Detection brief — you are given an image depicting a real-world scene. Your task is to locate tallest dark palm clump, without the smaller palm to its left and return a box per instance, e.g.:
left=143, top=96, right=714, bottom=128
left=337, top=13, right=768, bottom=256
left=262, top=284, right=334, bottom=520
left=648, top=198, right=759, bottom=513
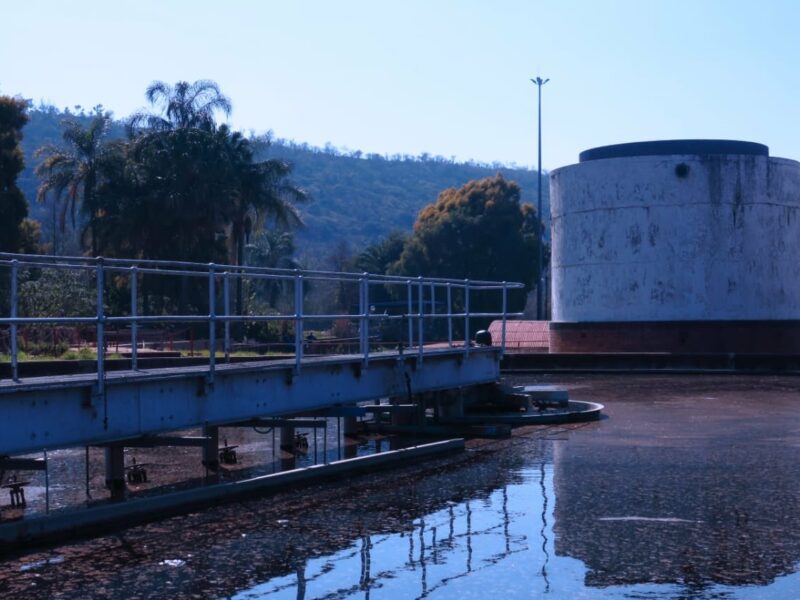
left=114, top=80, right=306, bottom=312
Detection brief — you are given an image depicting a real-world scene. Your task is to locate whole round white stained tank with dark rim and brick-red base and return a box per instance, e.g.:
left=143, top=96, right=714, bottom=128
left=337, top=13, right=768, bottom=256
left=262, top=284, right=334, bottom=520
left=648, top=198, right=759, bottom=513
left=550, top=140, right=800, bottom=353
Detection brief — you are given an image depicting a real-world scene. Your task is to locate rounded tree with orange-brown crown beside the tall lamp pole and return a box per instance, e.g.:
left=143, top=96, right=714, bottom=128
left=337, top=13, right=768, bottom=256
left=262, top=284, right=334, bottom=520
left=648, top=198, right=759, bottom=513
left=390, top=174, right=541, bottom=312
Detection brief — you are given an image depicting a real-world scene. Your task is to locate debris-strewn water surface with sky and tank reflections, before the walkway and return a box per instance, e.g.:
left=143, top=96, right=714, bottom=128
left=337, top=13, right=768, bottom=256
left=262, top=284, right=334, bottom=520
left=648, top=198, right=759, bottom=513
left=0, top=376, right=800, bottom=599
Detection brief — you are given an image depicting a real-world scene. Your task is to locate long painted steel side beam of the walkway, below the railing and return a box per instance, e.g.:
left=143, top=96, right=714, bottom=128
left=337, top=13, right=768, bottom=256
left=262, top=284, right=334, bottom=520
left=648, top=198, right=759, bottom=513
left=0, top=348, right=501, bottom=455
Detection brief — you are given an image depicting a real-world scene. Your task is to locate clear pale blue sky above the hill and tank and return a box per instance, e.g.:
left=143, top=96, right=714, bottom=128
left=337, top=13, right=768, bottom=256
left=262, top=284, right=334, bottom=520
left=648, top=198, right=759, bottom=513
left=0, top=0, right=800, bottom=169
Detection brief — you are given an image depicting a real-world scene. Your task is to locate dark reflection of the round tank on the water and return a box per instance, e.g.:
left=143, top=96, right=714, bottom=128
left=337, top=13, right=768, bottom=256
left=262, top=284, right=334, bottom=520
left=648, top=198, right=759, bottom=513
left=553, top=378, right=800, bottom=597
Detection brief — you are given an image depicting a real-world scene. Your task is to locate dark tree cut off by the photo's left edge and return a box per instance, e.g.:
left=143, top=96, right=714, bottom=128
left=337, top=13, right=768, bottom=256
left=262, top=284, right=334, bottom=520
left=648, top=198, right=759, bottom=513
left=0, top=96, right=28, bottom=252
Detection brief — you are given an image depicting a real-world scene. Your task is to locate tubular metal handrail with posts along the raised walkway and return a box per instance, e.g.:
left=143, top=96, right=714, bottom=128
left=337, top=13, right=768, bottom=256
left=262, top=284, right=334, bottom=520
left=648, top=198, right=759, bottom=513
left=0, top=253, right=523, bottom=382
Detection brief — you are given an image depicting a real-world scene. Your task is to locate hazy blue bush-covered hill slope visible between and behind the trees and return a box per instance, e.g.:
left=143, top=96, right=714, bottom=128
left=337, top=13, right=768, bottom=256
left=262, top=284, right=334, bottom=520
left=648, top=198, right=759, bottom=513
left=19, top=106, right=549, bottom=264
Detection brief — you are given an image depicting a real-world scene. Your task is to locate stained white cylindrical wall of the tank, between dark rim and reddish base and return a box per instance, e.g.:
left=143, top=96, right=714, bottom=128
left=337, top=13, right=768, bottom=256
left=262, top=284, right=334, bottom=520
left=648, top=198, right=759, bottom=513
left=550, top=154, right=800, bottom=322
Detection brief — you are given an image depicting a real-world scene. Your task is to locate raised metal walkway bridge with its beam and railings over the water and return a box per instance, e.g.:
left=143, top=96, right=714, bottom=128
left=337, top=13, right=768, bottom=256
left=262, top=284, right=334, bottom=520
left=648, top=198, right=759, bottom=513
left=0, top=254, right=522, bottom=465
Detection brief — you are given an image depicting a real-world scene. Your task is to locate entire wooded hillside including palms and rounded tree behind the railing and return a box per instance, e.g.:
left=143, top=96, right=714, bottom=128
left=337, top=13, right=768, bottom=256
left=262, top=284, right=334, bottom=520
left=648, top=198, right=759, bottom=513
left=0, top=80, right=542, bottom=350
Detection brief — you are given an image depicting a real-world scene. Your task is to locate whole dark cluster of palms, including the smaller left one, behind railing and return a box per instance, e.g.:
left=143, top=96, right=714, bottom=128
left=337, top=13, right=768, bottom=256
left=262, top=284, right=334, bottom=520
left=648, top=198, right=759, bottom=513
left=21, top=81, right=306, bottom=322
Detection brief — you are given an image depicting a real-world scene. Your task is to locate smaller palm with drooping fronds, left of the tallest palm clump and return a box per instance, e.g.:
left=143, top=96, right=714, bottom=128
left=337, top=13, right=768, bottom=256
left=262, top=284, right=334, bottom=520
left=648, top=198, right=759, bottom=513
left=35, top=113, right=111, bottom=255
